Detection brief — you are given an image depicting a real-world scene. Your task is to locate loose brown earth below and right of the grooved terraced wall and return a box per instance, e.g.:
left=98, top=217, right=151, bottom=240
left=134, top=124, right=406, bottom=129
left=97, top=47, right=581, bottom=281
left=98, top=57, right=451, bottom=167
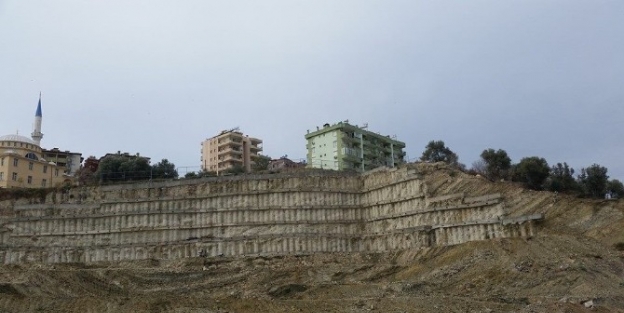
left=0, top=164, right=624, bottom=312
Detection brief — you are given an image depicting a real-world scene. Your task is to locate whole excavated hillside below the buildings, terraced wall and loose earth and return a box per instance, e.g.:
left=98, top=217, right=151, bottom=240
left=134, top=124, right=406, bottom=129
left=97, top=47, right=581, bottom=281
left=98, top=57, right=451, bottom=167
left=0, top=163, right=624, bottom=312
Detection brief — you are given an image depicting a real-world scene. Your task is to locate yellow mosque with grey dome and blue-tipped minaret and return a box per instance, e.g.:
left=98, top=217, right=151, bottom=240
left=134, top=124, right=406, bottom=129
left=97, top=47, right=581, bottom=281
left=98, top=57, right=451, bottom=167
left=0, top=94, right=82, bottom=188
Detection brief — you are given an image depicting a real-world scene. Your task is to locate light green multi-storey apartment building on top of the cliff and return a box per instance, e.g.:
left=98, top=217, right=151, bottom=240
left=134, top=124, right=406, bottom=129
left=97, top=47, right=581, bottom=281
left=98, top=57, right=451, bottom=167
left=305, top=121, right=405, bottom=172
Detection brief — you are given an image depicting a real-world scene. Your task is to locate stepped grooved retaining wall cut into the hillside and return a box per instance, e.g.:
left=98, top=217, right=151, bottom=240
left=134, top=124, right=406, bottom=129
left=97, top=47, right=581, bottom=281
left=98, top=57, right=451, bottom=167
left=0, top=168, right=541, bottom=264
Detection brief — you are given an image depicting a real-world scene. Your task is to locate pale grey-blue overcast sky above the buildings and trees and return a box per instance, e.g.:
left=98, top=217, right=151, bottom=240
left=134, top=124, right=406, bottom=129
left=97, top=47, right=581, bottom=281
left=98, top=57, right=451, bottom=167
left=0, top=0, right=624, bottom=180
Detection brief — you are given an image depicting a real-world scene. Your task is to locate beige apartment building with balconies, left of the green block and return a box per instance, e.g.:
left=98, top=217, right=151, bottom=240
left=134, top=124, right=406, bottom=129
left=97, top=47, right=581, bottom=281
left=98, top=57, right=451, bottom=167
left=201, top=128, right=262, bottom=174
